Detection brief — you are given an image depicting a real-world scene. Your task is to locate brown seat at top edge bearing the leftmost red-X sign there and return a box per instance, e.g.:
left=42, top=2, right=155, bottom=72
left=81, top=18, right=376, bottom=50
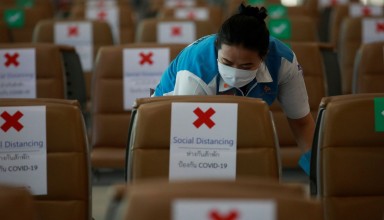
left=70, top=1, right=136, bottom=44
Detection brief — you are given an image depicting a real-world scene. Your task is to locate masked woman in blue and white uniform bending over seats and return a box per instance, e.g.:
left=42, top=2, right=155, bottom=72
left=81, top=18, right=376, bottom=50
left=154, top=4, right=314, bottom=173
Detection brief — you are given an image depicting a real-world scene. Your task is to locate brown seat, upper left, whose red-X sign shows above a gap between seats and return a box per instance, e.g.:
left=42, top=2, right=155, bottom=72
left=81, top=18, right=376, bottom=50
left=33, top=19, right=113, bottom=118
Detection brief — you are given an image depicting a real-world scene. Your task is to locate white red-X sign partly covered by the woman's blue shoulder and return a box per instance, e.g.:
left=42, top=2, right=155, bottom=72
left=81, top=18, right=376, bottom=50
left=123, top=48, right=170, bottom=110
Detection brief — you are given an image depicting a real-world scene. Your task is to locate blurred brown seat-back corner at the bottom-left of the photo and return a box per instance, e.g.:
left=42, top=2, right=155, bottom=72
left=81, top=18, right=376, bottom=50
left=0, top=184, right=38, bottom=220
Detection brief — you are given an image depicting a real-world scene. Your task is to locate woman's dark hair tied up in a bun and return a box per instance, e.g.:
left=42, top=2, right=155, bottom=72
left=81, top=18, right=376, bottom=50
left=216, top=3, right=269, bottom=58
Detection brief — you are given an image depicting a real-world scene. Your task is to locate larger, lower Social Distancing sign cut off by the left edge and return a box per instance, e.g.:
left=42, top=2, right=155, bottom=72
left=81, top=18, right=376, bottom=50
left=0, top=106, right=47, bottom=195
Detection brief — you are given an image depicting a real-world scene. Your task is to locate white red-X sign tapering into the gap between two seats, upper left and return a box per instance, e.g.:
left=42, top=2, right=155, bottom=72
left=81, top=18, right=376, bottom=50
left=54, top=22, right=93, bottom=72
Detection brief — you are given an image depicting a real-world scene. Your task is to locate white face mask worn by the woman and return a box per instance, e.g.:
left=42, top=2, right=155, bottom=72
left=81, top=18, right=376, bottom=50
left=217, top=61, right=257, bottom=88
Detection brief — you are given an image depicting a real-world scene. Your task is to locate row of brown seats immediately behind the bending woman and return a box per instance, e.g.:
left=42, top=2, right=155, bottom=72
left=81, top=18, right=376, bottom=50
left=1, top=37, right=383, bottom=169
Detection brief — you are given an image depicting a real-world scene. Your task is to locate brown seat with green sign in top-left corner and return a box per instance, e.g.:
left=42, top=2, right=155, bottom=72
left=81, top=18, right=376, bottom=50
left=0, top=5, right=54, bottom=43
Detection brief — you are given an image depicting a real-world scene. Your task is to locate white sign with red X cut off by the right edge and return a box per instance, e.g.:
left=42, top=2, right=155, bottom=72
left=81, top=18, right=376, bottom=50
left=362, top=18, right=384, bottom=43
